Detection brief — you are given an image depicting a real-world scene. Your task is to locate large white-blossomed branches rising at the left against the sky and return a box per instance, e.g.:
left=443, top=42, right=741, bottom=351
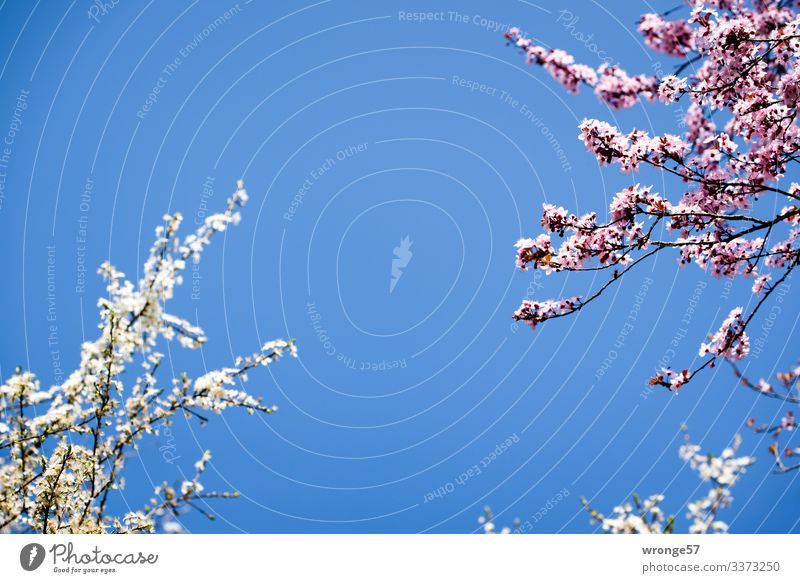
left=0, top=181, right=296, bottom=533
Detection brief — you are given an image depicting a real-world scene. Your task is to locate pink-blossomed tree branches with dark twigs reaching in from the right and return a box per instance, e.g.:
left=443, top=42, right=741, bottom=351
left=505, top=0, right=800, bottom=471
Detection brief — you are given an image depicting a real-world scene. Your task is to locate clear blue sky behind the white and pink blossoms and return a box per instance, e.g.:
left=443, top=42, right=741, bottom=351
left=0, top=0, right=800, bottom=533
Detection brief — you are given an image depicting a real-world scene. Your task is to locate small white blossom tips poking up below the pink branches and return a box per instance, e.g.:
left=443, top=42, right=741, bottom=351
left=478, top=434, right=755, bottom=534
